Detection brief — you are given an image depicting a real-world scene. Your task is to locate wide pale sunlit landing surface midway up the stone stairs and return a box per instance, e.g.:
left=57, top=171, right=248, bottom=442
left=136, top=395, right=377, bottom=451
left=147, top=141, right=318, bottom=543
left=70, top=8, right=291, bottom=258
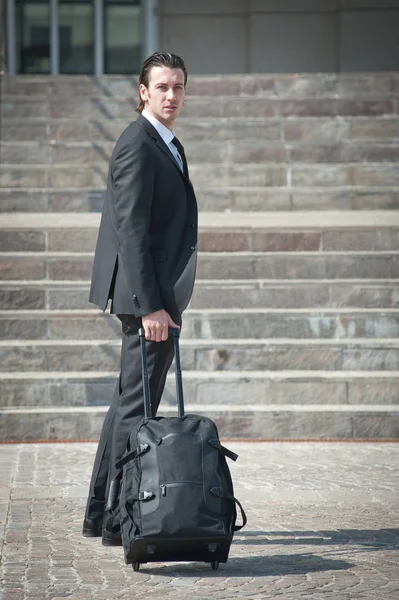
left=0, top=210, right=399, bottom=230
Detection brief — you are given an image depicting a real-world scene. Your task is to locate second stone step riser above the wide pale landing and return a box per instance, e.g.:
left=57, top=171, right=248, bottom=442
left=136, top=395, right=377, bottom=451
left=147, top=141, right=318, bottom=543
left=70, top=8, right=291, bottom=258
left=0, top=160, right=399, bottom=190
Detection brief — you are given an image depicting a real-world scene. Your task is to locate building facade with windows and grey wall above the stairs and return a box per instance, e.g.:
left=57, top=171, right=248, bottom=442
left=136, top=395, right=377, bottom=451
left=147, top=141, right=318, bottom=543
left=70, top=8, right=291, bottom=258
left=1, top=0, right=399, bottom=75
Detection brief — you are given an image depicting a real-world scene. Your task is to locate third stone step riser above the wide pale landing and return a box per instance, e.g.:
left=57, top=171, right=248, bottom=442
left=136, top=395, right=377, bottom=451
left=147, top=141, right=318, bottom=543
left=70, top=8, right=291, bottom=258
left=0, top=141, right=399, bottom=166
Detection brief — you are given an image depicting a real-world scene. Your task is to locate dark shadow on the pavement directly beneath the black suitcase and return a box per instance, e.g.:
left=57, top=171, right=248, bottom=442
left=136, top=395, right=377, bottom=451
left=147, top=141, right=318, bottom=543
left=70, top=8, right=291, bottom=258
left=140, top=553, right=354, bottom=578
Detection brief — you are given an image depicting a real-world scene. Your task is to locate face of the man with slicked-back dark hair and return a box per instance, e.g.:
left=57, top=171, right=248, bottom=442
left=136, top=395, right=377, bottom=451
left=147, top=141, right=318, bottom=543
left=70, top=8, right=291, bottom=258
left=139, top=66, right=185, bottom=131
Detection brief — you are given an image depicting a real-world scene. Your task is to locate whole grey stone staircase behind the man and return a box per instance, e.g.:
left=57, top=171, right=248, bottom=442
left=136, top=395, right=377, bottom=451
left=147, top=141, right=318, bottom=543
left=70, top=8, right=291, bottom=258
left=0, top=73, right=399, bottom=441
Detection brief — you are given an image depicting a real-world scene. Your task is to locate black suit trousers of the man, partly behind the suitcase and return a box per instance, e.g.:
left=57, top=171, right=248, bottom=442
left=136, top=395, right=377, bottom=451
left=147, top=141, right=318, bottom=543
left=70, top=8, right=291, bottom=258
left=85, top=315, right=180, bottom=521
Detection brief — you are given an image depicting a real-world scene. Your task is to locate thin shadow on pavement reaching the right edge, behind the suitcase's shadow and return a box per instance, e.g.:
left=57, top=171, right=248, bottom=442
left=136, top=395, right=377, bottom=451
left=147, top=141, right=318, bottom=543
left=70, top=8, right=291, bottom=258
left=238, top=529, right=399, bottom=550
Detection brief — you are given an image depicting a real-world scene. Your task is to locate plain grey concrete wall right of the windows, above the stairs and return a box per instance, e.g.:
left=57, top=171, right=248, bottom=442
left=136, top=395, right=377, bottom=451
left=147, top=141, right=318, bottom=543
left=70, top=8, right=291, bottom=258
left=160, top=0, right=399, bottom=74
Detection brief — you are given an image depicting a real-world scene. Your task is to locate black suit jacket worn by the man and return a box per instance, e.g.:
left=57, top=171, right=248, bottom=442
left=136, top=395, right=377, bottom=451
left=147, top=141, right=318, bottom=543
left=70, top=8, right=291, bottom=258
left=89, top=115, right=198, bottom=318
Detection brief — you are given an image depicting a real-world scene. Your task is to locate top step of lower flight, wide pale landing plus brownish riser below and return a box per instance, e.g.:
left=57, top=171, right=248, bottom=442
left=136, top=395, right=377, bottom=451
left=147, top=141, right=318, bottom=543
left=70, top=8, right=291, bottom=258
left=0, top=211, right=399, bottom=253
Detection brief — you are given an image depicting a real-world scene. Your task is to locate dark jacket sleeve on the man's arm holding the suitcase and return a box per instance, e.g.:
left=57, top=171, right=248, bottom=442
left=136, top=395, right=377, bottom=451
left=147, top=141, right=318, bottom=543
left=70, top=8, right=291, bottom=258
left=111, top=141, right=163, bottom=317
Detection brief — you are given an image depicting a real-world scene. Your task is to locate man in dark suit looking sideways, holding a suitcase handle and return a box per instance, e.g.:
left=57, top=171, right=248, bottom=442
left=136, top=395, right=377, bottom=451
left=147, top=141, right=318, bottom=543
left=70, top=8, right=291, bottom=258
left=83, top=52, right=197, bottom=545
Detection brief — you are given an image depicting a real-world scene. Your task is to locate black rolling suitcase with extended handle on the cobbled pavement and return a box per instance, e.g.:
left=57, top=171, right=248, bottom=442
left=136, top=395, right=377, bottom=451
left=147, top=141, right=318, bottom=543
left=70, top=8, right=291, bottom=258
left=108, top=329, right=246, bottom=571
